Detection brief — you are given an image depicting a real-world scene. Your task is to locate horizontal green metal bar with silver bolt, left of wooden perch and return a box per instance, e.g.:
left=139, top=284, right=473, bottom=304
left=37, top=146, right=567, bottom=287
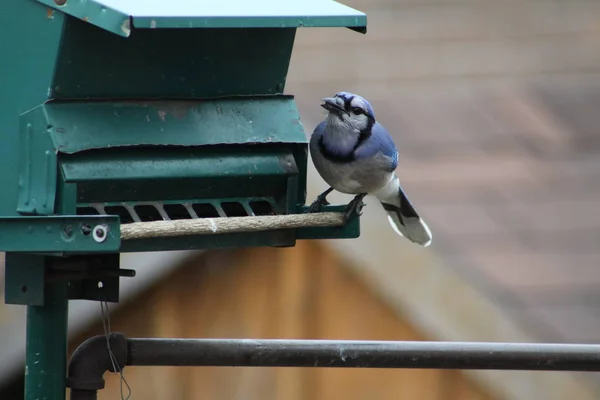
left=0, top=215, right=121, bottom=253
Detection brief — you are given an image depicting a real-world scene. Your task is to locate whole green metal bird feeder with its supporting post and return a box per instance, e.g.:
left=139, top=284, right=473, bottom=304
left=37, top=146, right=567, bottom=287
left=0, top=0, right=366, bottom=400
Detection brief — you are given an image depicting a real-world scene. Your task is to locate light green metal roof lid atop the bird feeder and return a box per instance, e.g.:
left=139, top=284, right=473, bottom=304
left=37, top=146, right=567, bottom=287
left=37, top=0, right=367, bottom=37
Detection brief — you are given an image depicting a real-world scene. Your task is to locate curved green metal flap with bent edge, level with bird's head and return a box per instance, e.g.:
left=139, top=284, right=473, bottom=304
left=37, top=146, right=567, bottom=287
left=32, top=96, right=306, bottom=154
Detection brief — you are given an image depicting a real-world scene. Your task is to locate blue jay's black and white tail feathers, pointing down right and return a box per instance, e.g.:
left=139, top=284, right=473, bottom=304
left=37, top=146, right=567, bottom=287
left=376, top=176, right=432, bottom=247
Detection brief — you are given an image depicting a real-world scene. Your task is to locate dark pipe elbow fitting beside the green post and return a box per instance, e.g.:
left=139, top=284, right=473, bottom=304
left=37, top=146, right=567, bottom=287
left=67, top=332, right=129, bottom=400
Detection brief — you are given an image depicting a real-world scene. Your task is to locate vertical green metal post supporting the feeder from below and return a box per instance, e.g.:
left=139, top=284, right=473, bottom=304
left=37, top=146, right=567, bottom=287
left=25, top=281, right=68, bottom=400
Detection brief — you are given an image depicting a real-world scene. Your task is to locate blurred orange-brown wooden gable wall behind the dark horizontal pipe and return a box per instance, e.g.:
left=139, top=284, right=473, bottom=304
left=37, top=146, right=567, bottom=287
left=70, top=242, right=491, bottom=400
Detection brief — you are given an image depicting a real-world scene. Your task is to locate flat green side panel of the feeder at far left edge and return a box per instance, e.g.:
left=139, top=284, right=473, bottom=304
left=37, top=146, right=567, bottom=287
left=0, top=0, right=64, bottom=216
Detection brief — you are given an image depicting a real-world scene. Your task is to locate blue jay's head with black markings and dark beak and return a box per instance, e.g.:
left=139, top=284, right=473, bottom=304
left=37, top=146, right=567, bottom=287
left=321, top=92, right=375, bottom=131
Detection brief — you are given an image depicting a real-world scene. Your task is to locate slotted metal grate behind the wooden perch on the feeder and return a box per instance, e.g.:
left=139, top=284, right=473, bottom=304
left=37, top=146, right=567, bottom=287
left=77, top=199, right=279, bottom=224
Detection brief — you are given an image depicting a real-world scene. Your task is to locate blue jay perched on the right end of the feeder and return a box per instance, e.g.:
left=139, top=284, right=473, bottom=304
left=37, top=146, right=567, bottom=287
left=308, top=92, right=432, bottom=247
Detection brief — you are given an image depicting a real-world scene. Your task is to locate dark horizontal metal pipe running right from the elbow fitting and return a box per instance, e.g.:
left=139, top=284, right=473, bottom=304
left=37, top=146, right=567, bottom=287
left=128, top=339, right=600, bottom=371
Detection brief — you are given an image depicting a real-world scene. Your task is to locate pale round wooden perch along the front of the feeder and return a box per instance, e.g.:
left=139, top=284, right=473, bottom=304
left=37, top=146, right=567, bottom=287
left=121, top=212, right=346, bottom=240
